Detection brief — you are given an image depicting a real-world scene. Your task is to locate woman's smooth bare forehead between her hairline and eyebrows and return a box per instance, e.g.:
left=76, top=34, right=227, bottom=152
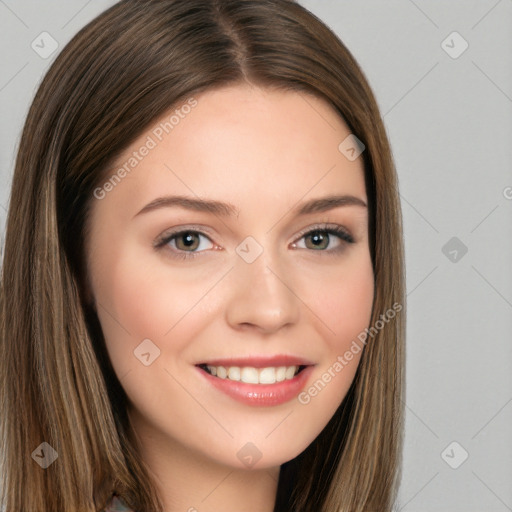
left=97, top=85, right=366, bottom=218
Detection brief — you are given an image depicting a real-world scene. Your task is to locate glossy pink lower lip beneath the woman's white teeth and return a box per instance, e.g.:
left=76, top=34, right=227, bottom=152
left=196, top=366, right=313, bottom=406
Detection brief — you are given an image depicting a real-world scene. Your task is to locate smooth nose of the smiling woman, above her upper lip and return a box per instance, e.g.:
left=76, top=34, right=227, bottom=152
left=226, top=250, right=301, bottom=334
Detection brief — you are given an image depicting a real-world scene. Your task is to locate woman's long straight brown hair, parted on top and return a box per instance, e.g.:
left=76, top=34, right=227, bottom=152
left=0, top=0, right=405, bottom=512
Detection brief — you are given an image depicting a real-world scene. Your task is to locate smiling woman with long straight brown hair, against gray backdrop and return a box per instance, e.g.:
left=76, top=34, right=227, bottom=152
left=0, top=0, right=405, bottom=512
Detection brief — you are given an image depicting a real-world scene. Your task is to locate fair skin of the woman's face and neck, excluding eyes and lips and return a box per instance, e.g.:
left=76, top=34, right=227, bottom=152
left=86, top=85, right=374, bottom=512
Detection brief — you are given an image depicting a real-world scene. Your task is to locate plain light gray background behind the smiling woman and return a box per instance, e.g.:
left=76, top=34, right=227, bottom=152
left=0, top=0, right=512, bottom=512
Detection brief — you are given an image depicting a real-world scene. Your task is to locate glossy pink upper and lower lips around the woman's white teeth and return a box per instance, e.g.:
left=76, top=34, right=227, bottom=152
left=196, top=356, right=314, bottom=406
